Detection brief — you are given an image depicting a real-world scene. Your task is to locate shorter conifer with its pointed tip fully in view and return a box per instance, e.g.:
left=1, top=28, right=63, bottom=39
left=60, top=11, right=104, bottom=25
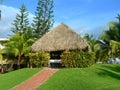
left=11, top=4, right=29, bottom=35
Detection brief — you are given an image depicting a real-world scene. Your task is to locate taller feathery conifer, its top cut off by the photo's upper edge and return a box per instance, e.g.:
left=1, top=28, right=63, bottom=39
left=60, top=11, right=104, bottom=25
left=32, top=0, right=54, bottom=39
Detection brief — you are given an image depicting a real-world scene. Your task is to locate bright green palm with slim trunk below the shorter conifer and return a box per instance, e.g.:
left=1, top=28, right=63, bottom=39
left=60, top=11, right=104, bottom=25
left=6, top=34, right=34, bottom=68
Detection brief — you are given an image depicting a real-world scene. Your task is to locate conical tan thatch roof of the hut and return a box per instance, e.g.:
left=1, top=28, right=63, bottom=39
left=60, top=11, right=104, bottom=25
left=31, top=23, right=88, bottom=52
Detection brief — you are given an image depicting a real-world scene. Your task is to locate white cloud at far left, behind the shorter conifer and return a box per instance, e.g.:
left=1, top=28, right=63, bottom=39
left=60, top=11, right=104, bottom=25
left=0, top=5, right=34, bottom=38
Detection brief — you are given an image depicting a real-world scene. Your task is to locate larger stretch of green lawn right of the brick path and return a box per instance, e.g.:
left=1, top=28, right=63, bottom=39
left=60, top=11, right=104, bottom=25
left=38, top=64, right=120, bottom=90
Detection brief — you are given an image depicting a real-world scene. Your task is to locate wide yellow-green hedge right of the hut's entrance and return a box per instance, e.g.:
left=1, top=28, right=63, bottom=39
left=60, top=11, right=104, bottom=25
left=61, top=51, right=95, bottom=68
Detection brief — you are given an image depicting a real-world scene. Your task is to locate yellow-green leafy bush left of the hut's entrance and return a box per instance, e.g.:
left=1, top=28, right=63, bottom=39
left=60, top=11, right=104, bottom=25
left=29, top=52, right=50, bottom=67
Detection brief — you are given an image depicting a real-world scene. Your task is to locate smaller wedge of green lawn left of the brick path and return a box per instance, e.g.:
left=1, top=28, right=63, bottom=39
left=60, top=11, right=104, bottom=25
left=0, top=68, right=41, bottom=90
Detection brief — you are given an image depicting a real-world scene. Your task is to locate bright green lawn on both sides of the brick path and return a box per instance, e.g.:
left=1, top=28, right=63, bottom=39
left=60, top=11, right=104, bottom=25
left=0, top=64, right=120, bottom=90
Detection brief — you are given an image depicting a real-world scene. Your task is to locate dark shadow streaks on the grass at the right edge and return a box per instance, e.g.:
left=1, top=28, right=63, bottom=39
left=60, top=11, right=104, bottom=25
left=98, top=65, right=120, bottom=80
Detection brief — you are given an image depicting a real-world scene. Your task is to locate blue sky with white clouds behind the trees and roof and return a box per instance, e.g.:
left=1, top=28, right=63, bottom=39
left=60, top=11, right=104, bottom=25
left=0, top=0, right=120, bottom=37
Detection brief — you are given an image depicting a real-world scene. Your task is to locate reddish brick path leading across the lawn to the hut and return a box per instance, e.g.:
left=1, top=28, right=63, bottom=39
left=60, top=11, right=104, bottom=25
left=12, top=68, right=58, bottom=90
